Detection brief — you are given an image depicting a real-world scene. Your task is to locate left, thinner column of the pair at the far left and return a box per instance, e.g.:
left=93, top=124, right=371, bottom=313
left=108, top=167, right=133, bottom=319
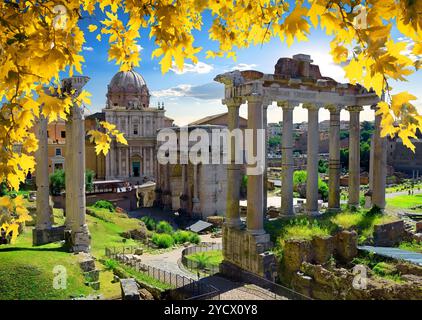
left=35, top=113, right=53, bottom=230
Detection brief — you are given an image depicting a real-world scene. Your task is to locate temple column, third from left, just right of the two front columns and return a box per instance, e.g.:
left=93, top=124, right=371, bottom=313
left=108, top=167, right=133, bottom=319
left=277, top=101, right=294, bottom=216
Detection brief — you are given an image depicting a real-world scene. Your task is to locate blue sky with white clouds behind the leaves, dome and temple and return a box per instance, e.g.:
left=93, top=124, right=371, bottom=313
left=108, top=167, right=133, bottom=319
left=77, top=7, right=422, bottom=125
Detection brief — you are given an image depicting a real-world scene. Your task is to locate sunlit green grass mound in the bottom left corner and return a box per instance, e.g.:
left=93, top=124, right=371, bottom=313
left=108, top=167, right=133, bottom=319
left=0, top=228, right=94, bottom=300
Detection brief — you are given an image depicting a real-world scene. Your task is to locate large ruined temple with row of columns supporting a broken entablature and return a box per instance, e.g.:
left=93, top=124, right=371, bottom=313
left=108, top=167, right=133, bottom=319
left=215, top=54, right=385, bottom=279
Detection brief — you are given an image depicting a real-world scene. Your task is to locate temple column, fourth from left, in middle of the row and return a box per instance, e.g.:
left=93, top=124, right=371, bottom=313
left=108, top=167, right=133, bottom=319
left=303, top=103, right=319, bottom=215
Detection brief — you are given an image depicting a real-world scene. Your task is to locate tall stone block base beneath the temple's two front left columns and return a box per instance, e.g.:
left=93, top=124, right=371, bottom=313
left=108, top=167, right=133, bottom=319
left=220, top=225, right=276, bottom=280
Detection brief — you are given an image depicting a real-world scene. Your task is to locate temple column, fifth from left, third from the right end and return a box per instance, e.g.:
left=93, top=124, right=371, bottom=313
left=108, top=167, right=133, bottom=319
left=327, top=105, right=341, bottom=212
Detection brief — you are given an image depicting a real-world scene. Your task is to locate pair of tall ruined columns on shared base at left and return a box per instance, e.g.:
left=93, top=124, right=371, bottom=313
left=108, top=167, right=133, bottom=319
left=33, top=76, right=91, bottom=252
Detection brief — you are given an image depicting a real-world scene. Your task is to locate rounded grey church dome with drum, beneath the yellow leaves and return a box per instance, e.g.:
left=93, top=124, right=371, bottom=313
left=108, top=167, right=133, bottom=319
left=107, top=70, right=150, bottom=109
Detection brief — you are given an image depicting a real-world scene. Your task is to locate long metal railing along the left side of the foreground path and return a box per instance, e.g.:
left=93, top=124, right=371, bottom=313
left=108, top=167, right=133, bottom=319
left=105, top=247, right=220, bottom=300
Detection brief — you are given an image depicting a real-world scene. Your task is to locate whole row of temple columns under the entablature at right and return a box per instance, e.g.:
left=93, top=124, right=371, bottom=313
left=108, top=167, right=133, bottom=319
left=223, top=96, right=386, bottom=224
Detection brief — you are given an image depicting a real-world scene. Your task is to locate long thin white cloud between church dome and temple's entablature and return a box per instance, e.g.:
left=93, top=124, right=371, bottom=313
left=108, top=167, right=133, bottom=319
left=152, top=82, right=224, bottom=100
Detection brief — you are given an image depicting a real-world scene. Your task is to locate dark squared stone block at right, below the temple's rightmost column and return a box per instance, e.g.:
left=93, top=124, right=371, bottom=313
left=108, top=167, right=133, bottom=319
left=374, top=220, right=406, bottom=247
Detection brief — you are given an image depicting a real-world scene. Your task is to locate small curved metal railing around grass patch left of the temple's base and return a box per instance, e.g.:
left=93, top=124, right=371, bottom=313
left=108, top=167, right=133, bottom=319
left=181, top=242, right=223, bottom=275
